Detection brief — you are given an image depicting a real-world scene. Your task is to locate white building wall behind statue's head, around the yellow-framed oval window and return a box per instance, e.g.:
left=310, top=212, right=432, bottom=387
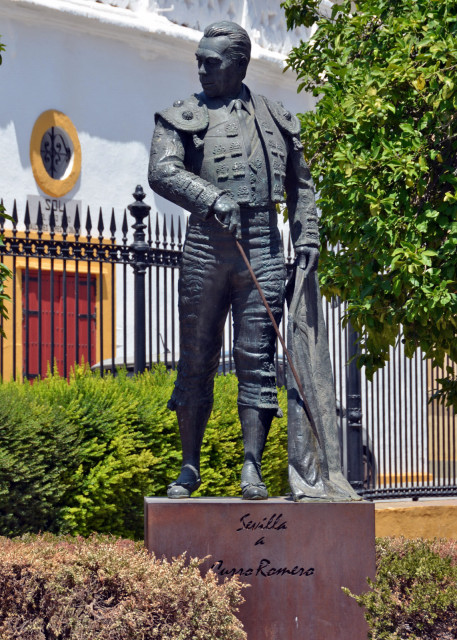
left=0, top=0, right=311, bottom=228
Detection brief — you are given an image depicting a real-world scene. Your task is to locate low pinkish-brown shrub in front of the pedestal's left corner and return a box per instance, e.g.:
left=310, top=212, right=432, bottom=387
left=0, top=534, right=246, bottom=640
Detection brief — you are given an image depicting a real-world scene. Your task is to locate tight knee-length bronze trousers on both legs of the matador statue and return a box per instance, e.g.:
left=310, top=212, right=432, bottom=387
left=168, top=208, right=286, bottom=411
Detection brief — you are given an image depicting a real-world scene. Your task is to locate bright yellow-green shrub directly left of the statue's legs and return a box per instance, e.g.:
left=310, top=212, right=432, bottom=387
left=35, top=368, right=166, bottom=538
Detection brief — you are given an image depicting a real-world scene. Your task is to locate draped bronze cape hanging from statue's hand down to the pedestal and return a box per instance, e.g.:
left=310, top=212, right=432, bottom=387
left=287, top=267, right=361, bottom=502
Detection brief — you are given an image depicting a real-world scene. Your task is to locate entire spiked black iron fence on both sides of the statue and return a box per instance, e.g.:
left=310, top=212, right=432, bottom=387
left=0, top=188, right=457, bottom=499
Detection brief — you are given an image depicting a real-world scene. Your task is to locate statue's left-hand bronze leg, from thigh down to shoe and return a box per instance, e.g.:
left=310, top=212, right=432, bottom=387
left=167, top=227, right=230, bottom=498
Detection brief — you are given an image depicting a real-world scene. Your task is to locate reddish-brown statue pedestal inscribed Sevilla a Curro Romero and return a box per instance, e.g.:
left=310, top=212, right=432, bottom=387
left=145, top=498, right=375, bottom=640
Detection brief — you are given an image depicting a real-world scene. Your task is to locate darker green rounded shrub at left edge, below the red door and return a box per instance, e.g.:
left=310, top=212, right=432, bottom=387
left=0, top=383, right=80, bottom=535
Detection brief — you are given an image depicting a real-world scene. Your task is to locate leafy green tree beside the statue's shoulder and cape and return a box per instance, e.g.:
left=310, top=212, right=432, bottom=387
left=281, top=0, right=457, bottom=408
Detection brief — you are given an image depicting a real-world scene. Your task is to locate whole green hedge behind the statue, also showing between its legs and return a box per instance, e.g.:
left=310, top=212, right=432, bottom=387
left=0, top=366, right=288, bottom=538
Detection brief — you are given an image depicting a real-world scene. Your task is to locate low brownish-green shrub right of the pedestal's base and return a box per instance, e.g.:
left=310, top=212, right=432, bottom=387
left=345, top=538, right=457, bottom=640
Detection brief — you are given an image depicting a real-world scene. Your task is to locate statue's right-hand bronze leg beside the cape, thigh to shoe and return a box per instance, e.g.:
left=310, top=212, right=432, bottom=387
left=232, top=225, right=285, bottom=500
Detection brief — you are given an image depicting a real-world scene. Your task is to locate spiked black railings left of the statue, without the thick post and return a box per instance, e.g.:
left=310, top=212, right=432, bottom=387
left=0, top=189, right=183, bottom=380
